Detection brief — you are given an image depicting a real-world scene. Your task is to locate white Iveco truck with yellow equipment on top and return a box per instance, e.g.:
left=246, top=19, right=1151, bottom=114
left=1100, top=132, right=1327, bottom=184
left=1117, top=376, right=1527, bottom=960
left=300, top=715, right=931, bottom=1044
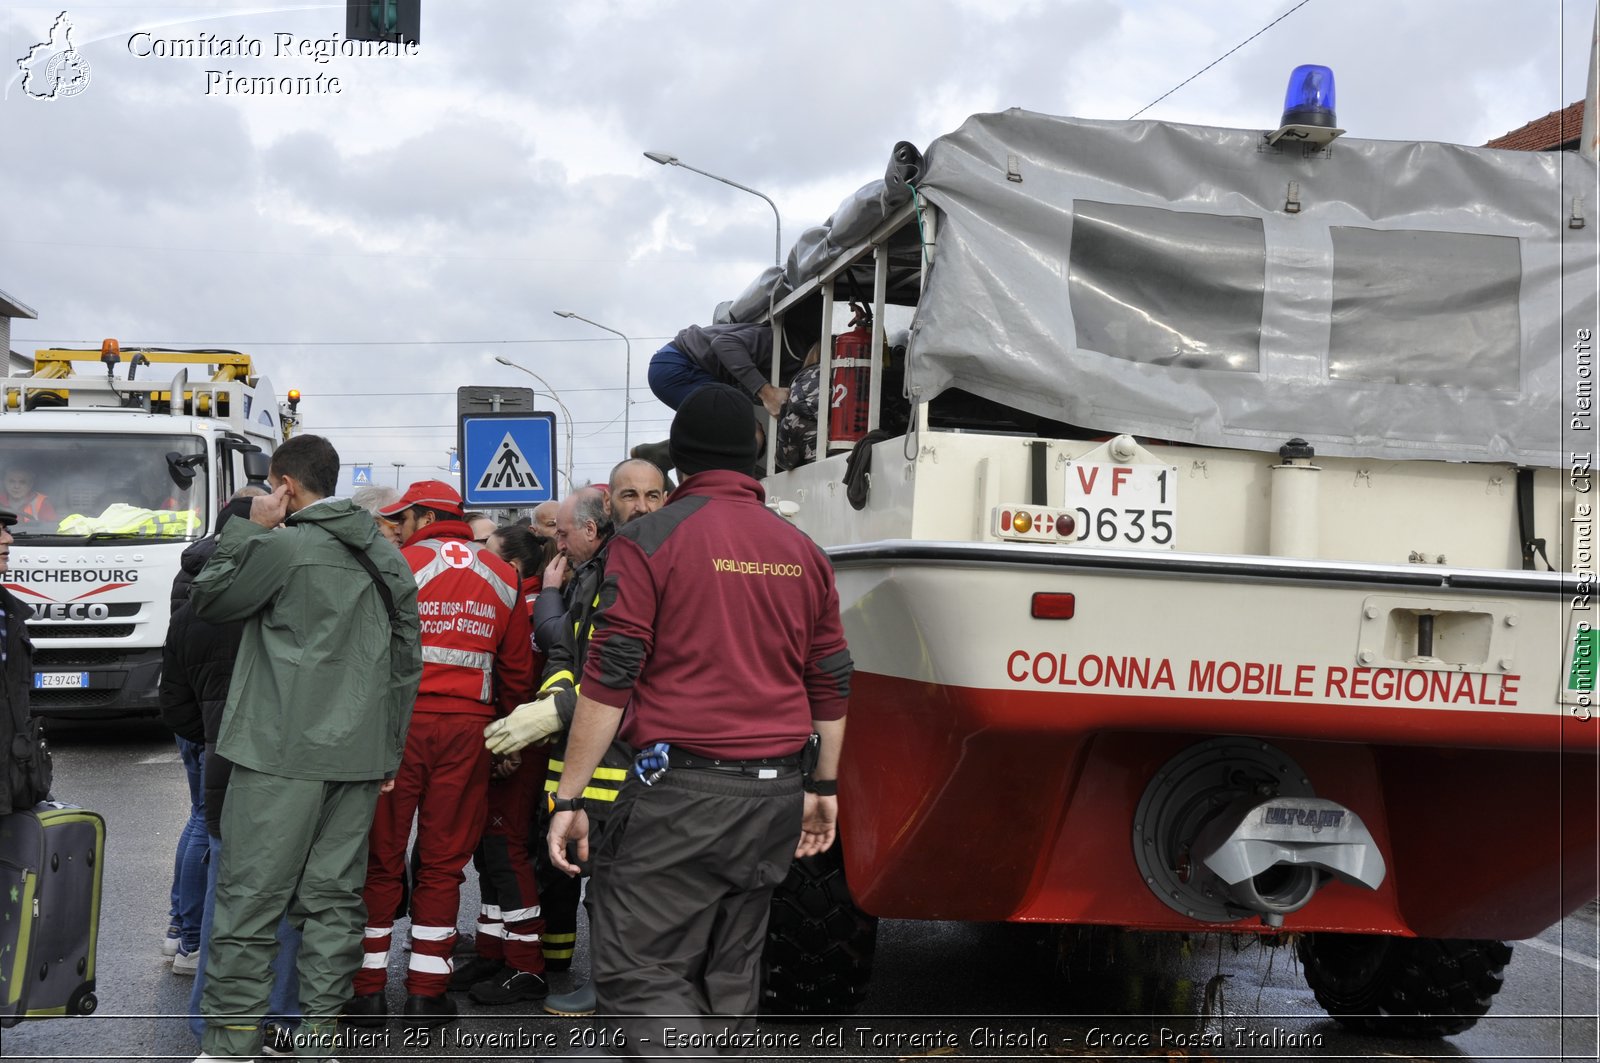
left=0, top=339, right=299, bottom=719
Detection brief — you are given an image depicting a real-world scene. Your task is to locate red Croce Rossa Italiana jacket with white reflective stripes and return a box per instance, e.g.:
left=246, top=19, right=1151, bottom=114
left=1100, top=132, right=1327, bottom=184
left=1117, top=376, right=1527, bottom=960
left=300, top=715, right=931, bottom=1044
left=400, top=520, right=536, bottom=717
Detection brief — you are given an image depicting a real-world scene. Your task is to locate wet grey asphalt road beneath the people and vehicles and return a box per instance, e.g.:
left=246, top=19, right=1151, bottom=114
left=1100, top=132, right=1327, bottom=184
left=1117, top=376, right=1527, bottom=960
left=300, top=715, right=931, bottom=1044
left=0, top=722, right=1600, bottom=1061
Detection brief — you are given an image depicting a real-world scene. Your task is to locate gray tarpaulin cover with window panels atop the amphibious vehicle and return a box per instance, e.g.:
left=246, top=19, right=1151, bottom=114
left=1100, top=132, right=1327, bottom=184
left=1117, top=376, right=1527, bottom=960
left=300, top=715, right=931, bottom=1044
left=746, top=110, right=1597, bottom=466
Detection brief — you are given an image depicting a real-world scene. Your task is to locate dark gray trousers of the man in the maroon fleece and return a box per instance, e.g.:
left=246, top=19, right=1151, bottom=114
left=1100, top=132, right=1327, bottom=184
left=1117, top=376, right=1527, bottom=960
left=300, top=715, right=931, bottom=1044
left=589, top=768, right=803, bottom=1057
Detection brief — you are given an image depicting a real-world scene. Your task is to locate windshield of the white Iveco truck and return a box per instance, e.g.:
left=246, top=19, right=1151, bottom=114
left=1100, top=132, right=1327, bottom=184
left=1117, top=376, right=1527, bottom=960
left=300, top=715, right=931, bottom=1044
left=0, top=432, right=211, bottom=541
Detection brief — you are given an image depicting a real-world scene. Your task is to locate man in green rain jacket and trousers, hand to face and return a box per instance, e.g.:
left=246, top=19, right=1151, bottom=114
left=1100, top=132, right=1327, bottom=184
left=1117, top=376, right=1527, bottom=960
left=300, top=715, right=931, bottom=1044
left=190, top=435, right=422, bottom=1058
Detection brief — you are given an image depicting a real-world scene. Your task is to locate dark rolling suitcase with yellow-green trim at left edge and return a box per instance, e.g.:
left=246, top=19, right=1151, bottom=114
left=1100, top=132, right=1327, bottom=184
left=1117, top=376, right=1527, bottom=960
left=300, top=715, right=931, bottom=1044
left=0, top=802, right=106, bottom=1028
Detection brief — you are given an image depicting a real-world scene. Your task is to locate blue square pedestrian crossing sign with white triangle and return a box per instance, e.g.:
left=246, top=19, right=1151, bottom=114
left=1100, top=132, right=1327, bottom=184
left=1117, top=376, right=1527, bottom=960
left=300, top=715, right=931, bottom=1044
left=458, top=413, right=555, bottom=506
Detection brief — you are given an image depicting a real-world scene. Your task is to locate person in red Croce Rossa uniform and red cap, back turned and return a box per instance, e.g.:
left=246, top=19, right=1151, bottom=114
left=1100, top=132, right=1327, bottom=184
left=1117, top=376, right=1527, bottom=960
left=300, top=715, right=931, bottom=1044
left=346, top=480, right=538, bottom=1025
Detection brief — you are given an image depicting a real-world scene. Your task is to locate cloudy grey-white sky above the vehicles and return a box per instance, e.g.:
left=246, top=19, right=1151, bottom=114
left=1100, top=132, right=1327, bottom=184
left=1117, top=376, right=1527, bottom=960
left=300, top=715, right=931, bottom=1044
left=0, top=0, right=1595, bottom=490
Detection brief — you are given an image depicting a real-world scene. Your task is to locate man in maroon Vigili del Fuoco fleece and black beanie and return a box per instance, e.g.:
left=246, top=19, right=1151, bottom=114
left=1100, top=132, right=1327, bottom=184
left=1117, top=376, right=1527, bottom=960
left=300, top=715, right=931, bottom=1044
left=549, top=384, right=851, bottom=1055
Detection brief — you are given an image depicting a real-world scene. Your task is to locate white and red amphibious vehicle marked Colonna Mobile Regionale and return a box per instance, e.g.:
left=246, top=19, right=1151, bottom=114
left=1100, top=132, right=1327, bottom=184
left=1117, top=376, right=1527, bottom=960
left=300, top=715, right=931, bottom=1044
left=748, top=67, right=1600, bottom=1034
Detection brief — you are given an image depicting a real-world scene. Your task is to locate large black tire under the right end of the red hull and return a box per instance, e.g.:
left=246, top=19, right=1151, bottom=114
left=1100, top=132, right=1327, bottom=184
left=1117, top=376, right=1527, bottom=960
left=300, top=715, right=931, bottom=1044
left=1298, top=933, right=1510, bottom=1037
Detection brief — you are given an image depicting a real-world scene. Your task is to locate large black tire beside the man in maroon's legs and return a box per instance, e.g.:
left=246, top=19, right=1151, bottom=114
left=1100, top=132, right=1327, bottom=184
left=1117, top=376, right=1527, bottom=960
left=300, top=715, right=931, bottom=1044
left=762, top=842, right=878, bottom=1015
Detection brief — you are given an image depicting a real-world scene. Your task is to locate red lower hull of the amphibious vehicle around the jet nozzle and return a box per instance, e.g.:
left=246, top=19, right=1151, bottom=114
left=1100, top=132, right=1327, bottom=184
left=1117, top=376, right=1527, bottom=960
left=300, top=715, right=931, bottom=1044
left=840, top=671, right=1600, bottom=940
